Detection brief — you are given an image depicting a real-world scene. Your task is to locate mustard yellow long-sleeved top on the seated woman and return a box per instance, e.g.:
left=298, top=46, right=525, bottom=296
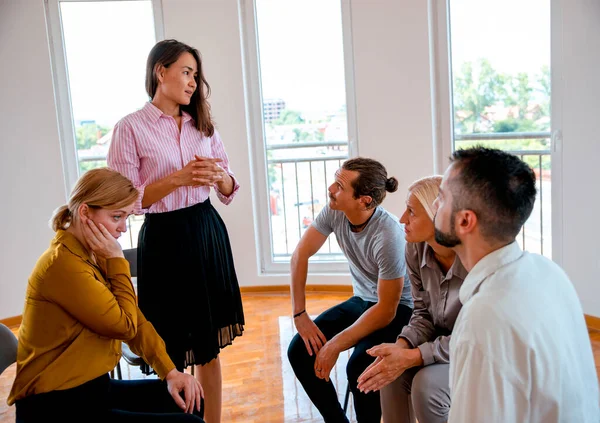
left=8, top=231, right=175, bottom=404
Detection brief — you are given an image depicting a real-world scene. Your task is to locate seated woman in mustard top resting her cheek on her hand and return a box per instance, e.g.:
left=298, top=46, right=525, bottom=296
left=8, top=169, right=203, bottom=423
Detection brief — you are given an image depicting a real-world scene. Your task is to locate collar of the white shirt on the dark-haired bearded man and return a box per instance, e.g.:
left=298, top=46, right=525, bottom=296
left=459, top=241, right=524, bottom=304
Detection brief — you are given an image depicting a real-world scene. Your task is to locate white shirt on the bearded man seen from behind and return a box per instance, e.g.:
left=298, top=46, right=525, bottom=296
left=448, top=242, right=600, bottom=423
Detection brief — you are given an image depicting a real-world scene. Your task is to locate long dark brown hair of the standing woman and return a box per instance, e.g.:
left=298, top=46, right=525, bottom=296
left=146, top=40, right=215, bottom=137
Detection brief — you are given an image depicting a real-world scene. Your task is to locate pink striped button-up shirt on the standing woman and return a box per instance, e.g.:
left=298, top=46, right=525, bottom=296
left=106, top=103, right=240, bottom=214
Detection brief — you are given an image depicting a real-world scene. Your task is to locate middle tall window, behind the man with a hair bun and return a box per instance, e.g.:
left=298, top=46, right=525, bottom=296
left=245, top=0, right=355, bottom=271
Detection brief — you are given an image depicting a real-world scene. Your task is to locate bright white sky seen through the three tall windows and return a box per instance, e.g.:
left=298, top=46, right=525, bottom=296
left=61, top=0, right=550, bottom=125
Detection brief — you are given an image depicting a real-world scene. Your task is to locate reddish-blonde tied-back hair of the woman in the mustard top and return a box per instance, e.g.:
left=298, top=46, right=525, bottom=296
left=50, top=167, right=139, bottom=232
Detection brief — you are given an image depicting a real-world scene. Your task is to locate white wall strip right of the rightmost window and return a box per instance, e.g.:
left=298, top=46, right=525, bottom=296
left=552, top=0, right=600, bottom=316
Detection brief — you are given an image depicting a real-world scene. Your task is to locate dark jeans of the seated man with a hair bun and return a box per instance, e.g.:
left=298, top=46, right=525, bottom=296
left=288, top=297, right=412, bottom=423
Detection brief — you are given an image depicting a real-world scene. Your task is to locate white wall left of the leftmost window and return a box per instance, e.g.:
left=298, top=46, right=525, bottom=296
left=0, top=0, right=65, bottom=319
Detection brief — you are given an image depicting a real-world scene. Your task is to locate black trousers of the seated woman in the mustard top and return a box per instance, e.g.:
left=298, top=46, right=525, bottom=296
left=16, top=375, right=204, bottom=423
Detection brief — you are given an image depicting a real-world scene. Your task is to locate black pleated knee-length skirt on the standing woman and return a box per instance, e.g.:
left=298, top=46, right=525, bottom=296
left=137, top=199, right=244, bottom=374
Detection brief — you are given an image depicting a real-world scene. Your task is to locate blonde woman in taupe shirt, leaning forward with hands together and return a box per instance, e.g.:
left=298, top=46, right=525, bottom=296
left=359, top=176, right=467, bottom=423
